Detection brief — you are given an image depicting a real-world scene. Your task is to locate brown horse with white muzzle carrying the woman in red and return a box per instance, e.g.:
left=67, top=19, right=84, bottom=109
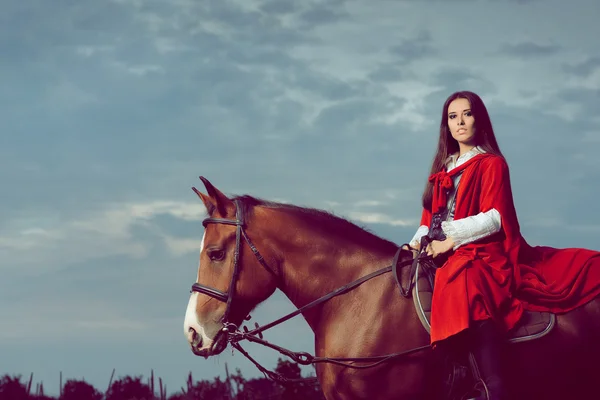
left=184, top=177, right=600, bottom=400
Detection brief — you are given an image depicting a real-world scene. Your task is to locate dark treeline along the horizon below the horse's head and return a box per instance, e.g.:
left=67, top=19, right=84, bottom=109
left=0, top=359, right=325, bottom=400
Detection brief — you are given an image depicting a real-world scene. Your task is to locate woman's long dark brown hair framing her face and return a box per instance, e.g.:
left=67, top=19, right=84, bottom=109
left=422, top=90, right=504, bottom=210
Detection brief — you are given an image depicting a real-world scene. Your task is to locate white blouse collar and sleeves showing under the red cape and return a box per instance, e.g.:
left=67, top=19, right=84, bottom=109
left=409, top=146, right=501, bottom=250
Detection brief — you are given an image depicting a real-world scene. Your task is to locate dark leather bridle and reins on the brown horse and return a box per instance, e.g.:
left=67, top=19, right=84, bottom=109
left=190, top=200, right=431, bottom=384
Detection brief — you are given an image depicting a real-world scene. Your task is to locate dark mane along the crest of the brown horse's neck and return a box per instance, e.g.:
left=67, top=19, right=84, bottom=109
left=232, top=195, right=398, bottom=249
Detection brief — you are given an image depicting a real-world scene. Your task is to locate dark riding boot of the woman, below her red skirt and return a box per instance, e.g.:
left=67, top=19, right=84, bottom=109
left=470, top=320, right=507, bottom=400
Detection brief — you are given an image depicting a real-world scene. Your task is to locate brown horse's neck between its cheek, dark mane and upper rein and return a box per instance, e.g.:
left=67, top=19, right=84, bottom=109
left=266, top=209, right=395, bottom=329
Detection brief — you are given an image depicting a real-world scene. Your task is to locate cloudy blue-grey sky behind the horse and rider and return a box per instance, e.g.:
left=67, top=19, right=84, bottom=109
left=0, top=0, right=600, bottom=393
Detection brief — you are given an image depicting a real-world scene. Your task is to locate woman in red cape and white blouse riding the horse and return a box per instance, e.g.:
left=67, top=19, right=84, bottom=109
left=410, top=91, right=600, bottom=399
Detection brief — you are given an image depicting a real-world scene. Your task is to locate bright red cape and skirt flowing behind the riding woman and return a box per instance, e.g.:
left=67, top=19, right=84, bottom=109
left=421, top=154, right=600, bottom=343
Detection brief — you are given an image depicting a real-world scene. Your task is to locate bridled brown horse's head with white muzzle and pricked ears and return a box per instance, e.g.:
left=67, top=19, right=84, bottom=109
left=184, top=177, right=276, bottom=357
